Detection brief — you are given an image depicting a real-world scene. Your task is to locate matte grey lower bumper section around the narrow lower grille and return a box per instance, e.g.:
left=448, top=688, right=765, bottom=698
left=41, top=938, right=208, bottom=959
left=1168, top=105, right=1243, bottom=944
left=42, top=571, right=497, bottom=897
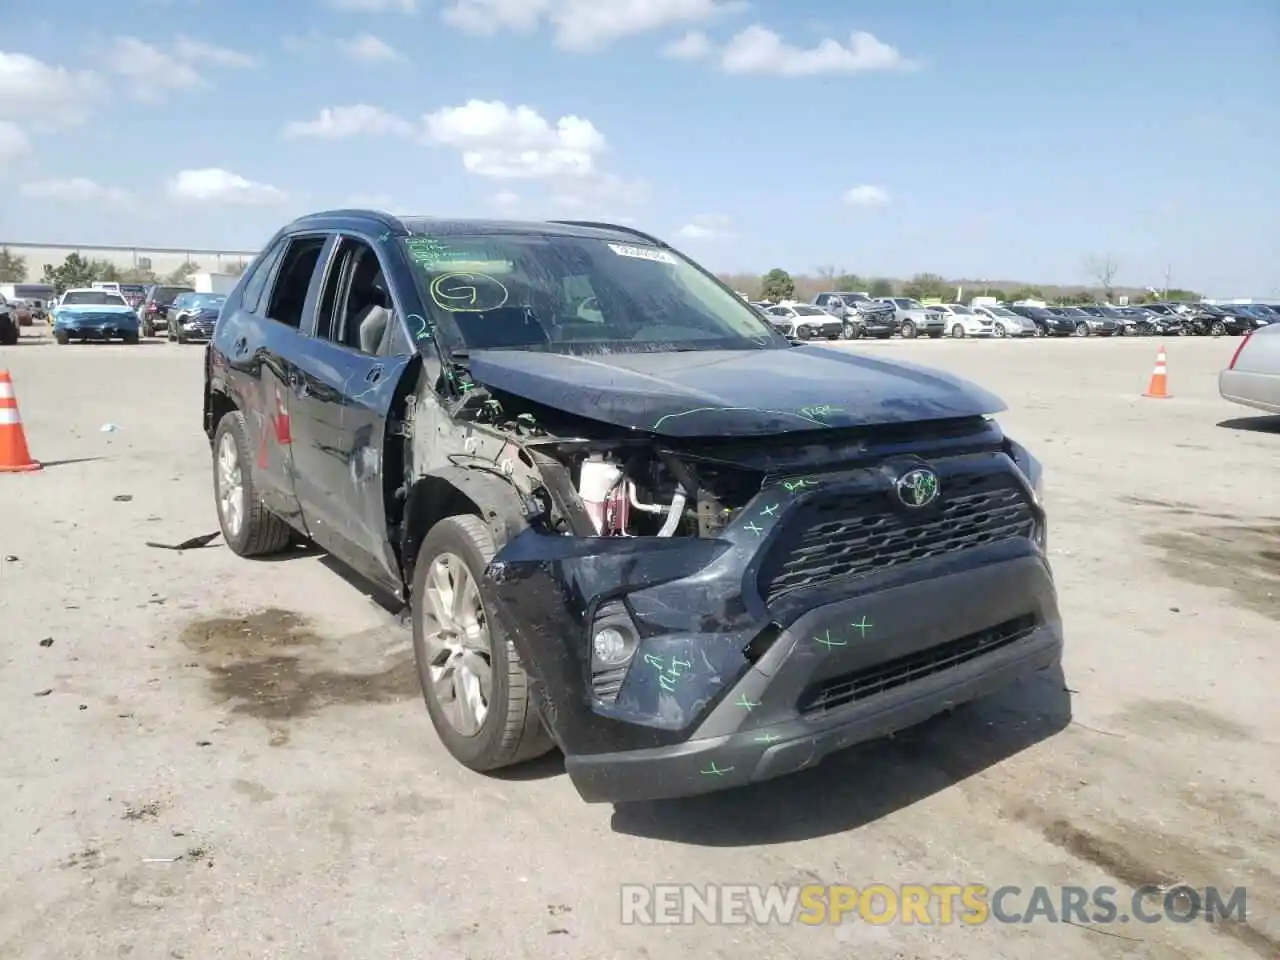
left=564, top=558, right=1062, bottom=803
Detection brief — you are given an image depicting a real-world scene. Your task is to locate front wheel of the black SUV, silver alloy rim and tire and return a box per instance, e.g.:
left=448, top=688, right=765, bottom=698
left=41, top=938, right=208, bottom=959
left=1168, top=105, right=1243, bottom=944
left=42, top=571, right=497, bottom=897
left=411, top=516, right=554, bottom=771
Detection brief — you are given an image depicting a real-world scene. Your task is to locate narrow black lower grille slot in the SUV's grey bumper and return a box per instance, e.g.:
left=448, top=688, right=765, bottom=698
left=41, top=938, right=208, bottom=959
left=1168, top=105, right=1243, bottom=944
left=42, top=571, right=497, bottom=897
left=799, top=614, right=1037, bottom=713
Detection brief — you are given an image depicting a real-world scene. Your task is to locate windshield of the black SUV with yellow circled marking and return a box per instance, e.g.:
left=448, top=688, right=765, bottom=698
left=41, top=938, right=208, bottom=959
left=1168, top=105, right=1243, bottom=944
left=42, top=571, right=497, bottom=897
left=401, top=234, right=783, bottom=353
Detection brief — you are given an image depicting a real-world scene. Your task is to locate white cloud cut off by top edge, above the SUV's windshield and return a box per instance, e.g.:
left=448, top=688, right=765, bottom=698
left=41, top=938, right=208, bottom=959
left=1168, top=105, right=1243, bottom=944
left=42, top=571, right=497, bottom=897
left=443, top=0, right=745, bottom=52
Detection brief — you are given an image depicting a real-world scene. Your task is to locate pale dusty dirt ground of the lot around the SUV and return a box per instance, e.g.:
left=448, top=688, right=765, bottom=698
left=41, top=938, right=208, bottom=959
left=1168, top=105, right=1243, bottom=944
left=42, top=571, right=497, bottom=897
left=0, top=332, right=1280, bottom=960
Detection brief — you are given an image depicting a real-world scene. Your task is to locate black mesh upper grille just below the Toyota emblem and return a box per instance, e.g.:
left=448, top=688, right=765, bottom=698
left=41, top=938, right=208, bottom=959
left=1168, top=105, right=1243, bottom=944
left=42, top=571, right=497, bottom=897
left=759, top=474, right=1036, bottom=600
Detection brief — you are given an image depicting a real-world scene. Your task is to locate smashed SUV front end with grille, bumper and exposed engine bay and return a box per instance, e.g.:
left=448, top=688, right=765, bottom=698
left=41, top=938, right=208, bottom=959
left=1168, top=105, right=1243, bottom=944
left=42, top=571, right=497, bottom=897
left=402, top=353, right=1061, bottom=801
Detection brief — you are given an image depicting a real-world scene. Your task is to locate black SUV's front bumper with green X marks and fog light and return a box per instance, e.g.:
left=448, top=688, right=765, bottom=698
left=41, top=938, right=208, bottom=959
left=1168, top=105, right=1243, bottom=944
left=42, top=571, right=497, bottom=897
left=483, top=454, right=1062, bottom=803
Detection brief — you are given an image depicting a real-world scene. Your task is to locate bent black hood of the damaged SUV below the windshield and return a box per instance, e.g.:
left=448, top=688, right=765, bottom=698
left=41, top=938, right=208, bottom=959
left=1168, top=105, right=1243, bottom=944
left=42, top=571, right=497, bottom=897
left=470, top=346, right=1006, bottom=436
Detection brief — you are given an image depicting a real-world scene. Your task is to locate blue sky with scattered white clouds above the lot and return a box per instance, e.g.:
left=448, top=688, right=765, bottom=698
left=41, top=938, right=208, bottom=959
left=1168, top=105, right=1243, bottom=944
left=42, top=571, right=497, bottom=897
left=0, top=0, right=1280, bottom=296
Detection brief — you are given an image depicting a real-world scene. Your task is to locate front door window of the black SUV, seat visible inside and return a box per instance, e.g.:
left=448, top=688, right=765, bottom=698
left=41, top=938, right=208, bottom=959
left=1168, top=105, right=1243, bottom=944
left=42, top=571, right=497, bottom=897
left=316, top=237, right=398, bottom=357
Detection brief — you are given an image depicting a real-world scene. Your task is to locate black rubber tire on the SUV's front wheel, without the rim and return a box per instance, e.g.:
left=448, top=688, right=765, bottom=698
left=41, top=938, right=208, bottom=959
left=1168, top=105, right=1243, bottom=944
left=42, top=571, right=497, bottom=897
left=410, top=515, right=554, bottom=772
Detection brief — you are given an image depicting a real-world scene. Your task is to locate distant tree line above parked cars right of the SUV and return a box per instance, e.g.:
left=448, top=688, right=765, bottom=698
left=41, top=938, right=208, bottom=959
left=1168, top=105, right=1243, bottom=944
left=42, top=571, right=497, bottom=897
left=719, top=260, right=1201, bottom=306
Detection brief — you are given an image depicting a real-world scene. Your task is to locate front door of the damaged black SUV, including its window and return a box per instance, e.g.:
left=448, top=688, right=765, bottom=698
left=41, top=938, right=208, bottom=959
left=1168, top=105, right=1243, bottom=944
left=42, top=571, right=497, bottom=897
left=296, top=233, right=413, bottom=590
